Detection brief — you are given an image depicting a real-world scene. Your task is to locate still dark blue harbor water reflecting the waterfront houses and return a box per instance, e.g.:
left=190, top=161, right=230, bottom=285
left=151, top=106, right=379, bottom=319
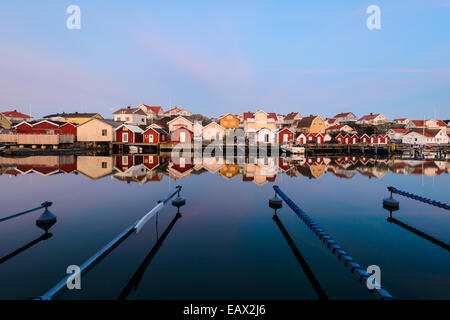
left=0, top=155, right=450, bottom=299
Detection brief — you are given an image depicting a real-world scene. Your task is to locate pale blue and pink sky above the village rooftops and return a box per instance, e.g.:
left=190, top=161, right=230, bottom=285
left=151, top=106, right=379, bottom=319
left=0, top=0, right=450, bottom=119
